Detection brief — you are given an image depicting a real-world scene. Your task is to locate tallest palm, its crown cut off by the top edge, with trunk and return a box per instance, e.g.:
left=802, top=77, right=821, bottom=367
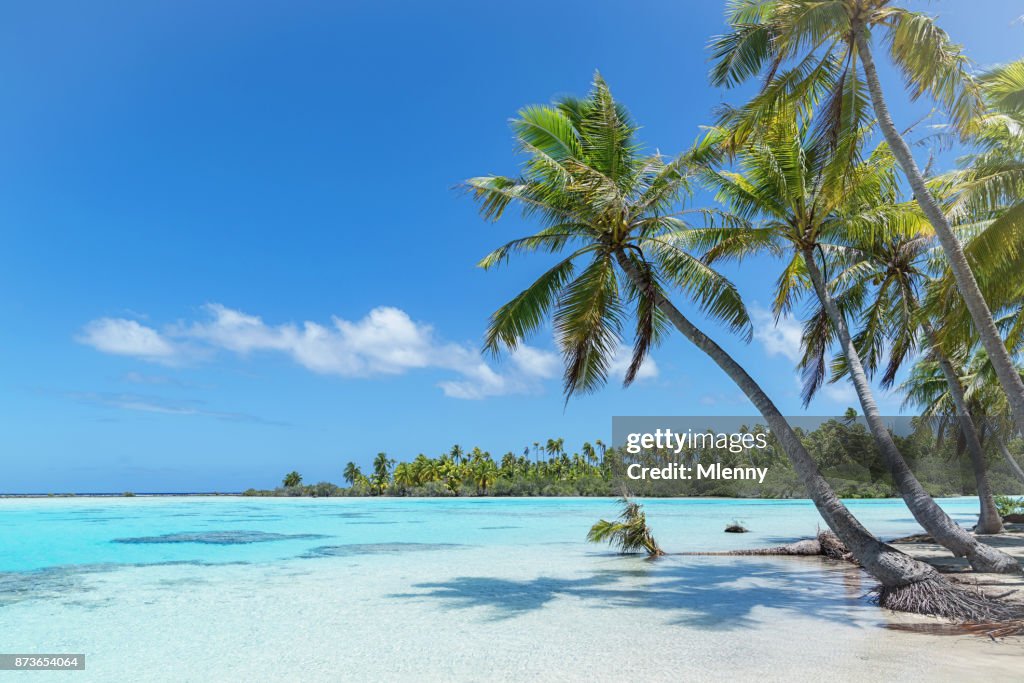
left=711, top=0, right=1024, bottom=438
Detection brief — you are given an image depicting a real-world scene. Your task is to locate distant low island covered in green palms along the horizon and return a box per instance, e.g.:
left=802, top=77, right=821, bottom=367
left=243, top=418, right=1024, bottom=499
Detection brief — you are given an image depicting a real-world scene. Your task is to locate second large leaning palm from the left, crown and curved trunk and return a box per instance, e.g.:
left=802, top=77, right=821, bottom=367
left=691, top=106, right=1020, bottom=572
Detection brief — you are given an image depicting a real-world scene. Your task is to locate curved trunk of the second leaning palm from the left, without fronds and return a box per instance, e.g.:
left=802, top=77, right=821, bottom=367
left=804, top=249, right=1020, bottom=573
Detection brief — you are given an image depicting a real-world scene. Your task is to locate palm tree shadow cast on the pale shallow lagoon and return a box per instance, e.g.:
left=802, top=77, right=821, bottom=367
left=392, top=557, right=870, bottom=631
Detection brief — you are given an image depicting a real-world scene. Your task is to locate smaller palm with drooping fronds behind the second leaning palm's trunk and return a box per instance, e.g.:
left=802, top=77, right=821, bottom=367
left=802, top=233, right=1002, bottom=533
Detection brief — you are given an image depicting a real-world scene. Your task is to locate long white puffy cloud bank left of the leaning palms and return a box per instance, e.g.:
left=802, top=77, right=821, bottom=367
left=78, top=304, right=569, bottom=399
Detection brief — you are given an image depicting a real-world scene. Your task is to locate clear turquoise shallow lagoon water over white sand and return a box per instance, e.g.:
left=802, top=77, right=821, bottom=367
left=0, top=498, right=1024, bottom=681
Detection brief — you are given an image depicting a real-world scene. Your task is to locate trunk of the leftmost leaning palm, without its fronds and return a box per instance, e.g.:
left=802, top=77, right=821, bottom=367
left=616, top=253, right=945, bottom=591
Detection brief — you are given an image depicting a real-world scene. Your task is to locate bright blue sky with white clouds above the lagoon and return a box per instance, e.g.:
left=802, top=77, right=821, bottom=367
left=0, top=0, right=1024, bottom=493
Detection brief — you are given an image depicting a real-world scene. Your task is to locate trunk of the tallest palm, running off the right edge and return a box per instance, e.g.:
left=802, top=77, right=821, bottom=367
left=855, top=29, right=1024, bottom=431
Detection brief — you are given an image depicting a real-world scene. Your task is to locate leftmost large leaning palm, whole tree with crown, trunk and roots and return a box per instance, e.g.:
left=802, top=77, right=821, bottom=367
left=467, top=75, right=1007, bottom=618
